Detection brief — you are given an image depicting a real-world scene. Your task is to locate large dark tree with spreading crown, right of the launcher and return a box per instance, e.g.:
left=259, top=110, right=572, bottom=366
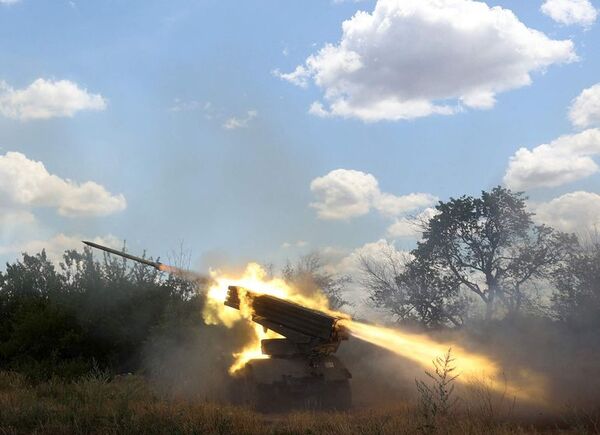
left=412, top=186, right=577, bottom=320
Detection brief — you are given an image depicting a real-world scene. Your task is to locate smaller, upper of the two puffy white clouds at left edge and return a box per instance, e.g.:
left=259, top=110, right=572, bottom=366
left=0, top=78, right=106, bottom=121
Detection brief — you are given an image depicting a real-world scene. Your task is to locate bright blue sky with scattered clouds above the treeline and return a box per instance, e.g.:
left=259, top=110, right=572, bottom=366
left=0, top=0, right=600, bottom=280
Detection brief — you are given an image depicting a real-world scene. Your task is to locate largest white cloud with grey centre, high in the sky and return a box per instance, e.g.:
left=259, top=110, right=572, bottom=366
left=276, top=0, right=577, bottom=121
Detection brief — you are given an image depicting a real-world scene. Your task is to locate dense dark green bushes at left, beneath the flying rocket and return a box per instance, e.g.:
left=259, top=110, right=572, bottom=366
left=0, top=245, right=201, bottom=380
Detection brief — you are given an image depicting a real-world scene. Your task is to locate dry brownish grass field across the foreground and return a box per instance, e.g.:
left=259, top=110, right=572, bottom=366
left=0, top=372, right=599, bottom=435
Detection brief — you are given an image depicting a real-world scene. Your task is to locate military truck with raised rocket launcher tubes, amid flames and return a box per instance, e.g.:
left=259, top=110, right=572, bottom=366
left=225, top=286, right=352, bottom=411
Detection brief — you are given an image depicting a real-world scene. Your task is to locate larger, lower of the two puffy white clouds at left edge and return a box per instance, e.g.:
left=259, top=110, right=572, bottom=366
left=0, top=152, right=127, bottom=217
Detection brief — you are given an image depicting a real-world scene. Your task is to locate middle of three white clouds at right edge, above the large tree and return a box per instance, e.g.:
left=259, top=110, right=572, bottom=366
left=504, top=129, right=600, bottom=190
